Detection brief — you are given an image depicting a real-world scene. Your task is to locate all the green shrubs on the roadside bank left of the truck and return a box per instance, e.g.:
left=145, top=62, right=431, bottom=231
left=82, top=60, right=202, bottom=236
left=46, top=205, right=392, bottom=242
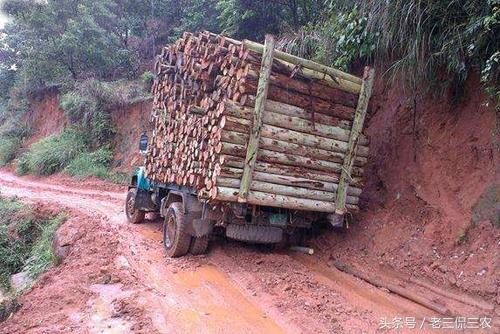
left=13, top=80, right=148, bottom=182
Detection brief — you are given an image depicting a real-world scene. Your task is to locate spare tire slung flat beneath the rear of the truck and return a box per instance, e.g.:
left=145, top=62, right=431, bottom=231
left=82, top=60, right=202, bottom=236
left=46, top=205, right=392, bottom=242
left=226, top=224, right=283, bottom=244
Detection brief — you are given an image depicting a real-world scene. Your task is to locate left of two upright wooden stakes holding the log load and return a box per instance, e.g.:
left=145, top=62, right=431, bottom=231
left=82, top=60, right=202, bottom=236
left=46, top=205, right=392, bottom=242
left=238, top=35, right=275, bottom=203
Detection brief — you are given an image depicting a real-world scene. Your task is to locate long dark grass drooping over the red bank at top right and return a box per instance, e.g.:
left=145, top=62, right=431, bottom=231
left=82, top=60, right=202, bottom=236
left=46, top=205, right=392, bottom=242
left=360, top=0, right=500, bottom=88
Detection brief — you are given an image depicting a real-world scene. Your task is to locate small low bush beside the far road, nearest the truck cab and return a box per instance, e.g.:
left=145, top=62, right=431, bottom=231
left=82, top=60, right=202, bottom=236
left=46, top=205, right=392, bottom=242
left=64, top=148, right=113, bottom=179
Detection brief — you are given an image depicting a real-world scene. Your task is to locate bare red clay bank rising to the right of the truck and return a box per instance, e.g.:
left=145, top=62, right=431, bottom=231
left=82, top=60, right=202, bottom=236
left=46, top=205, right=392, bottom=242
left=313, top=72, right=500, bottom=304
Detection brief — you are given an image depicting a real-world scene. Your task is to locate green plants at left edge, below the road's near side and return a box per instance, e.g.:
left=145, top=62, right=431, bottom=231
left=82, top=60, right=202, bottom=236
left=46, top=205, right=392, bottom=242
left=0, top=197, right=65, bottom=288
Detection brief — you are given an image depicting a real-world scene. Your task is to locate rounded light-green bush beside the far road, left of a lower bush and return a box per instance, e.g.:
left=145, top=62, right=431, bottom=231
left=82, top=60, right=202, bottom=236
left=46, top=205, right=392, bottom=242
left=16, top=128, right=86, bottom=175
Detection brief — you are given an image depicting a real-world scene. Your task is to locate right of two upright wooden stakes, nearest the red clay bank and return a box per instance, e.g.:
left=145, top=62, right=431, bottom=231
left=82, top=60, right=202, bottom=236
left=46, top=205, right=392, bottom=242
left=335, top=67, right=375, bottom=215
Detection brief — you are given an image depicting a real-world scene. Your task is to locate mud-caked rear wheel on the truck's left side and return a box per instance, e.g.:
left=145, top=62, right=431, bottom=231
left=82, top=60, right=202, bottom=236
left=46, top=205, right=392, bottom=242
left=163, top=202, right=191, bottom=257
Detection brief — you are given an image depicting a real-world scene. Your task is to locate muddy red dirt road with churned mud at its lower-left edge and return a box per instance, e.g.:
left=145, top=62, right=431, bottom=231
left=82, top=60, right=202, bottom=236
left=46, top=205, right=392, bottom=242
left=0, top=171, right=494, bottom=333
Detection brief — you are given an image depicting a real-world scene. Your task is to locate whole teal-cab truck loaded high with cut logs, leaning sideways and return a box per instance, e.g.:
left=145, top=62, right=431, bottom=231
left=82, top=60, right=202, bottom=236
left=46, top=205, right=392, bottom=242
left=126, top=32, right=374, bottom=257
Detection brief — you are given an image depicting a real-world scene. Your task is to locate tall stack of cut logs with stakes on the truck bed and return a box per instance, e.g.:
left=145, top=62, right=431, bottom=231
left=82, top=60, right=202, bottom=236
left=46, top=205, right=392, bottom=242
left=146, top=32, right=373, bottom=212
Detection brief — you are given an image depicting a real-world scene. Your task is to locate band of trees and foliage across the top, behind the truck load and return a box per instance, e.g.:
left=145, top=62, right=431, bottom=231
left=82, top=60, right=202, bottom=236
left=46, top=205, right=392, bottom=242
left=0, top=0, right=494, bottom=103
